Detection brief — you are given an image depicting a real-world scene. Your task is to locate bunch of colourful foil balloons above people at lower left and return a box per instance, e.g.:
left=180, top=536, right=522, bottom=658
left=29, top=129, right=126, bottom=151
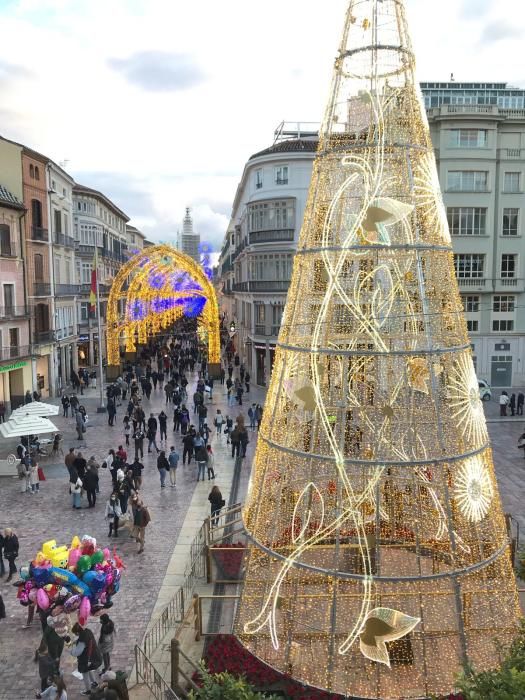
left=16, top=535, right=125, bottom=626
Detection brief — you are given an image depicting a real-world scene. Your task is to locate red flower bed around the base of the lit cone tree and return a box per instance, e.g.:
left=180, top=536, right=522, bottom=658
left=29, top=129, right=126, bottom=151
left=199, top=634, right=464, bottom=700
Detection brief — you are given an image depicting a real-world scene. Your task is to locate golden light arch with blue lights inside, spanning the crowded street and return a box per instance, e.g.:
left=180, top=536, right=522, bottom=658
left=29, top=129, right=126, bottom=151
left=107, top=244, right=220, bottom=367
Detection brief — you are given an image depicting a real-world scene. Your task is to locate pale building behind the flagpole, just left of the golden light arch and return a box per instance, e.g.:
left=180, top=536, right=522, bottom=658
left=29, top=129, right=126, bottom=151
left=73, top=184, right=129, bottom=367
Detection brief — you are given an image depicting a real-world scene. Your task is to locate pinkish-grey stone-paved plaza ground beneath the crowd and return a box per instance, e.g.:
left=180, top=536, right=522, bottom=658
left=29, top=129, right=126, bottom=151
left=0, top=370, right=263, bottom=700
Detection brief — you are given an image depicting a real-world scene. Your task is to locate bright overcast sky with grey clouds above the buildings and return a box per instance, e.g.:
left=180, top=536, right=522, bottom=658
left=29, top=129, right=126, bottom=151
left=0, top=0, right=525, bottom=249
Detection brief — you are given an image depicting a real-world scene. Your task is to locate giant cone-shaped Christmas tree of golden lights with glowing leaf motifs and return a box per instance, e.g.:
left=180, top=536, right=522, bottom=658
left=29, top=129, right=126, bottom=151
left=236, top=0, right=518, bottom=698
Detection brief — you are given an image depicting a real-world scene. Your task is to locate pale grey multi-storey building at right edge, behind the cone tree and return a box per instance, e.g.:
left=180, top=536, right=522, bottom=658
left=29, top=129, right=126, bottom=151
left=421, top=82, right=525, bottom=387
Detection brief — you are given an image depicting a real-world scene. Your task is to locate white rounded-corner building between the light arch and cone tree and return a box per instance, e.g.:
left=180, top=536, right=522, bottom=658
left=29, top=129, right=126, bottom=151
left=218, top=123, right=317, bottom=386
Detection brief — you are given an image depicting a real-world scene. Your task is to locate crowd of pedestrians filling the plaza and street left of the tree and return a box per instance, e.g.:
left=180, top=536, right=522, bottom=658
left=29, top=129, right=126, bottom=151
left=0, top=326, right=262, bottom=700
